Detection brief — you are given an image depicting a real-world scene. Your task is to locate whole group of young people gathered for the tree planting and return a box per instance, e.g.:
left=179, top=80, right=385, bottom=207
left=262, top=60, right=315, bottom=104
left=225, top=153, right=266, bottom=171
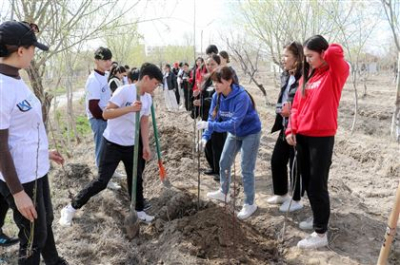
left=0, top=21, right=349, bottom=264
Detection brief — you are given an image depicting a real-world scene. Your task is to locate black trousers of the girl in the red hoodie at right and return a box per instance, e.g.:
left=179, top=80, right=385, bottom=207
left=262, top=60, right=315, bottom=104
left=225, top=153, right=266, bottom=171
left=296, top=134, right=335, bottom=234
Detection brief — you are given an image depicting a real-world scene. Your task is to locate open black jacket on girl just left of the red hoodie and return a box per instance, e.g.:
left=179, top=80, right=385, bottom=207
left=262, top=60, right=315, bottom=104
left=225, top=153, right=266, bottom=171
left=271, top=71, right=301, bottom=133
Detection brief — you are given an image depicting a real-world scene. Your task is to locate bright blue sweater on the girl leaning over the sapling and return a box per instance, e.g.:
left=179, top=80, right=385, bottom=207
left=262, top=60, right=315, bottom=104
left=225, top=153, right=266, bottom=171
left=203, top=84, right=261, bottom=141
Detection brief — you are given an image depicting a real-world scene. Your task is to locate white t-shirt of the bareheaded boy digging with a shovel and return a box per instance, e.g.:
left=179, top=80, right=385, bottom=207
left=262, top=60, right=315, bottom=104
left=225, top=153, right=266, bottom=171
left=103, top=84, right=152, bottom=146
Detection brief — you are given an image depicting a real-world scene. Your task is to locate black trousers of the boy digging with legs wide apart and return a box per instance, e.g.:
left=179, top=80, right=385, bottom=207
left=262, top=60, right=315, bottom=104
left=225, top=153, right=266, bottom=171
left=71, top=137, right=144, bottom=211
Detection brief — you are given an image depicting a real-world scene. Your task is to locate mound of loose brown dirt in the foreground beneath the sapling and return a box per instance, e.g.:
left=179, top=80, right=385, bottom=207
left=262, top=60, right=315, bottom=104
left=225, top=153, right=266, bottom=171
left=131, top=189, right=285, bottom=264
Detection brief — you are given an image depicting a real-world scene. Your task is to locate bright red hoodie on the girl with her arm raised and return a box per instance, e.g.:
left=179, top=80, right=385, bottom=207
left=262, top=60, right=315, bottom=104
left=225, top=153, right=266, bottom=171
left=286, top=44, right=350, bottom=137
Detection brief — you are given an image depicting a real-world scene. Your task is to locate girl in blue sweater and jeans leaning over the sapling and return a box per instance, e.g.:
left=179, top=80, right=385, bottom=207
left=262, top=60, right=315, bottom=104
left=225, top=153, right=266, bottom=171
left=197, top=66, right=261, bottom=219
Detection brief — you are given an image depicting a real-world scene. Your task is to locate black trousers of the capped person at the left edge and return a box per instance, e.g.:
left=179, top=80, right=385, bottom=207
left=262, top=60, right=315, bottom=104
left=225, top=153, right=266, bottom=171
left=0, top=175, right=60, bottom=265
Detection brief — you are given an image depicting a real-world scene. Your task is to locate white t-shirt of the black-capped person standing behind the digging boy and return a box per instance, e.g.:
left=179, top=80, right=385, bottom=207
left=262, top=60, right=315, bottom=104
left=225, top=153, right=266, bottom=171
left=85, top=71, right=111, bottom=119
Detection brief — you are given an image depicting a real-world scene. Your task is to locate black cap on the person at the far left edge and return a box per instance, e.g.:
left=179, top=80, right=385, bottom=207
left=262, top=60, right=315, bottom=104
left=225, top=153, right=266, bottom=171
left=0, top=21, right=49, bottom=51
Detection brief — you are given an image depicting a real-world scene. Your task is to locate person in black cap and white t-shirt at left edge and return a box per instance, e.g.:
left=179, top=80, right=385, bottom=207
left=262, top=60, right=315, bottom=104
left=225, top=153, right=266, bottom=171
left=0, top=21, right=68, bottom=265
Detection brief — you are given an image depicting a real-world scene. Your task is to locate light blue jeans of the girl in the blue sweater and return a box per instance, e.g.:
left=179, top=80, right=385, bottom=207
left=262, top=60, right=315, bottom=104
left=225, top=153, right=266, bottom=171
left=219, top=132, right=261, bottom=205
